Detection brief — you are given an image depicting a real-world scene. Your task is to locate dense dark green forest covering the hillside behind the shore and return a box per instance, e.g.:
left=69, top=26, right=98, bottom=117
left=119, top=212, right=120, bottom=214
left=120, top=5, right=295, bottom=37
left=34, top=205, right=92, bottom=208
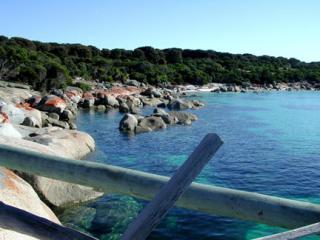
left=0, top=36, right=320, bottom=90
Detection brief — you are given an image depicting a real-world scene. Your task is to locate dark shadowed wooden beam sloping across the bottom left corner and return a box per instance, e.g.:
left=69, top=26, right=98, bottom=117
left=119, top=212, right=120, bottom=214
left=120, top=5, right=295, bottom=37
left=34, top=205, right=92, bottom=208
left=0, top=201, right=97, bottom=240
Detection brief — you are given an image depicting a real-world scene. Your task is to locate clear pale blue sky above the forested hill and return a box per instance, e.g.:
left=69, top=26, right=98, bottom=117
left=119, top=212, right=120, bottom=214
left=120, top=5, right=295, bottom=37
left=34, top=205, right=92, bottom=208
left=0, top=0, right=320, bottom=62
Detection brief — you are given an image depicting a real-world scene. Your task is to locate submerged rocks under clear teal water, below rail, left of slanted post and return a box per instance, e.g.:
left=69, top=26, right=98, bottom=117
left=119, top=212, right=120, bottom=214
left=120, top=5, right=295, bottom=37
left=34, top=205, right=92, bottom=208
left=59, top=195, right=143, bottom=240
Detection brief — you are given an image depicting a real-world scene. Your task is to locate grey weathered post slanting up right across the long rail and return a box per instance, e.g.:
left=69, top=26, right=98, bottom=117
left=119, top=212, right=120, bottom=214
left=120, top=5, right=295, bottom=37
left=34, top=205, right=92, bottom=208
left=122, top=133, right=223, bottom=240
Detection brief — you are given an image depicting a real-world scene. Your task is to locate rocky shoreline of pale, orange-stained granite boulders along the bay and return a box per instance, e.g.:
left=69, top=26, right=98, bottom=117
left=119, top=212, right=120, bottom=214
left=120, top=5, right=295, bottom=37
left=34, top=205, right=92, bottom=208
left=0, top=80, right=320, bottom=239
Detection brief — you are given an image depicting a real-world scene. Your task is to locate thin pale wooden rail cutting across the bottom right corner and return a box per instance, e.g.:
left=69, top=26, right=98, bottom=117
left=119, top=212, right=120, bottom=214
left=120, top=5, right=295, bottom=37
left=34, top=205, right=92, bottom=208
left=256, top=223, right=320, bottom=240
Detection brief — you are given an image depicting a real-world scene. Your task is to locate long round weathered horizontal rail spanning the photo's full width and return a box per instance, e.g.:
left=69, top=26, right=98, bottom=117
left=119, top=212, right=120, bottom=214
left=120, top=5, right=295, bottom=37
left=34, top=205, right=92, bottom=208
left=0, top=134, right=320, bottom=239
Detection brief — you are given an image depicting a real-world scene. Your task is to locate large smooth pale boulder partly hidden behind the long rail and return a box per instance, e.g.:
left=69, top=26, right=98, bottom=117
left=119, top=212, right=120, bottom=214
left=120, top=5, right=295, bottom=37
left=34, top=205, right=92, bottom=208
left=0, top=126, right=102, bottom=207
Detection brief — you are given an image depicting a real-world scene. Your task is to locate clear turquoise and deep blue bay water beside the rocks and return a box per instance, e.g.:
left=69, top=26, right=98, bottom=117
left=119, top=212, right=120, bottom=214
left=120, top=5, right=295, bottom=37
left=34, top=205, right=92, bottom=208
left=60, top=92, right=320, bottom=240
